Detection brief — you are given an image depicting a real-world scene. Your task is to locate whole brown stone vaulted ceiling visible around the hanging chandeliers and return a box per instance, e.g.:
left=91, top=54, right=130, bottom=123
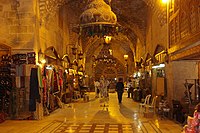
left=40, top=0, right=147, bottom=63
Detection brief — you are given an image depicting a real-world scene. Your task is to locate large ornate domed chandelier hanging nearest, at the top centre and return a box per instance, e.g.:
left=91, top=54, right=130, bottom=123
left=75, top=0, right=120, bottom=37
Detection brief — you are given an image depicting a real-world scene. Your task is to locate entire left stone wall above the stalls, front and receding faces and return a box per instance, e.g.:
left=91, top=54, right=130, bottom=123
left=0, top=0, right=75, bottom=63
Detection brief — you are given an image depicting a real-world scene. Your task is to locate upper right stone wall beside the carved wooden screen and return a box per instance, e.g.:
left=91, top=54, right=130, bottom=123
left=136, top=8, right=168, bottom=60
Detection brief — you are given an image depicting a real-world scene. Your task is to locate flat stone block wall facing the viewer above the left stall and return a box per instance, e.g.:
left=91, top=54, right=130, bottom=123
left=0, top=0, right=35, bottom=53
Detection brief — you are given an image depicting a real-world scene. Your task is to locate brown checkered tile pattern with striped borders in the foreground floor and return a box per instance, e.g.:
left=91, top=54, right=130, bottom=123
left=38, top=121, right=162, bottom=133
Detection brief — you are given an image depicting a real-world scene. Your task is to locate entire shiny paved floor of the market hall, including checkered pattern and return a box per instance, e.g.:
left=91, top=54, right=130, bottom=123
left=0, top=93, right=182, bottom=133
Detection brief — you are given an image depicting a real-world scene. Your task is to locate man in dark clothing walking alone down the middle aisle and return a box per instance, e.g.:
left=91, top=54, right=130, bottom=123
left=116, top=78, right=124, bottom=103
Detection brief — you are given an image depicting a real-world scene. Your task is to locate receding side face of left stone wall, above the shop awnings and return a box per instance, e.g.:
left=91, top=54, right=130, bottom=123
left=37, top=3, right=75, bottom=57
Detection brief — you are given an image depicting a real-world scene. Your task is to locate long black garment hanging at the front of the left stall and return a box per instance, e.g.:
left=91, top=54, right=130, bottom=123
left=29, top=68, right=40, bottom=112
